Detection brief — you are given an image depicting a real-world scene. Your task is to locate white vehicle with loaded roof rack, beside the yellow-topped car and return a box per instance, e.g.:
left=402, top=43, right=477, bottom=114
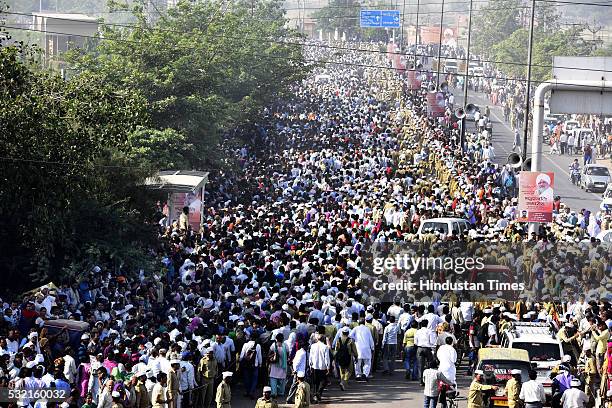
left=501, top=322, right=563, bottom=398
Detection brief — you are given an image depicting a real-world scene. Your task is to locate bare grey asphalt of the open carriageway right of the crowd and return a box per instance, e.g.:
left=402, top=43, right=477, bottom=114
left=453, top=88, right=602, bottom=211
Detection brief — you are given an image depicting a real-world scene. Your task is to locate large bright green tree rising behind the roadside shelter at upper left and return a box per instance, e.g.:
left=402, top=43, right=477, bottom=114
left=69, top=0, right=307, bottom=168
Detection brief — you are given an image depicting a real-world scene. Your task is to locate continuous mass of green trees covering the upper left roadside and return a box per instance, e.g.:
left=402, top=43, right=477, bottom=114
left=0, top=1, right=308, bottom=288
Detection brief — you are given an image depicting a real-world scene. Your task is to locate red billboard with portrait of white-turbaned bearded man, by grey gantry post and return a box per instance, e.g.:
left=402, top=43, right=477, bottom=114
left=518, top=171, right=555, bottom=222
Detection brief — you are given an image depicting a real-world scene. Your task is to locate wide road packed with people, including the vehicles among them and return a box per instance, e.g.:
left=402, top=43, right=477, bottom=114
left=0, top=39, right=612, bottom=408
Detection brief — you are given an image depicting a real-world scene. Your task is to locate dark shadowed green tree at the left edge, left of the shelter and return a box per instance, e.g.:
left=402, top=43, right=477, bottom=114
left=0, top=40, right=177, bottom=289
